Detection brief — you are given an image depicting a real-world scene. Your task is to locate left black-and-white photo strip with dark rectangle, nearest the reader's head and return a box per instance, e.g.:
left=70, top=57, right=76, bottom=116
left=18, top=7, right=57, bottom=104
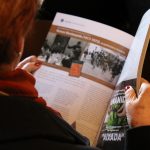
left=38, top=32, right=88, bottom=68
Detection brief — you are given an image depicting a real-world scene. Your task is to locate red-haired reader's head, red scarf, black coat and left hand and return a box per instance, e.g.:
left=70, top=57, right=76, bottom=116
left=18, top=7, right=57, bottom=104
left=0, top=0, right=97, bottom=150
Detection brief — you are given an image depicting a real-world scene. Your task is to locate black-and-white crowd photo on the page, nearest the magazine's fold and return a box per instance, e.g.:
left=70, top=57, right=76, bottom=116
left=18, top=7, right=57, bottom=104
left=81, top=43, right=125, bottom=85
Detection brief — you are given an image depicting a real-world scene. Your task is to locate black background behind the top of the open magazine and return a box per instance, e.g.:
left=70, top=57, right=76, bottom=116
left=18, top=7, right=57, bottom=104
left=23, top=0, right=150, bottom=81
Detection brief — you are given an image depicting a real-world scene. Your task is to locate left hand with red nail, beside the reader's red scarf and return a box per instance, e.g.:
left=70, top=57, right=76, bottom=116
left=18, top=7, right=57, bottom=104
left=16, top=55, right=42, bottom=73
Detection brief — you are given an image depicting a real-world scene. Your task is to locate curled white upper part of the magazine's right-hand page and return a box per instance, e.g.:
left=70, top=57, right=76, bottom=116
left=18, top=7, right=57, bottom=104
left=118, top=10, right=150, bottom=90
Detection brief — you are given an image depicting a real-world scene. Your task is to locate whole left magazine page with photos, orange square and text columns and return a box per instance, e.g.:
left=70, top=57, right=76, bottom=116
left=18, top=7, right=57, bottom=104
left=34, top=13, right=133, bottom=145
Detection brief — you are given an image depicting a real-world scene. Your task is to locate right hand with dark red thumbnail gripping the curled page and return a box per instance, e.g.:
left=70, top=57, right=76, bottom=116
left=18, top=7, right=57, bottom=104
left=125, top=79, right=150, bottom=127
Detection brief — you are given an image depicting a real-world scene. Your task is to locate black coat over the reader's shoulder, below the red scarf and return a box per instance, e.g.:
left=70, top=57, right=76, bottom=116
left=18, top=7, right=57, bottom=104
left=0, top=96, right=99, bottom=150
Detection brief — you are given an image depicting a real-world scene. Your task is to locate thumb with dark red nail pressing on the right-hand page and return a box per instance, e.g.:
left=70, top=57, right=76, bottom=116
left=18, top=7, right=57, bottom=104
left=125, top=86, right=136, bottom=101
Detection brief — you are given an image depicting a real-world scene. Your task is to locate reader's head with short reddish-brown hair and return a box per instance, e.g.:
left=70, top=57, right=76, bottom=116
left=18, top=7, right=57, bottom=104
left=0, top=0, right=38, bottom=68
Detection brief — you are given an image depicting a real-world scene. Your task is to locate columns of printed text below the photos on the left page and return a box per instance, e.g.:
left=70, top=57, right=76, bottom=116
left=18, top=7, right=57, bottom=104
left=34, top=65, right=113, bottom=144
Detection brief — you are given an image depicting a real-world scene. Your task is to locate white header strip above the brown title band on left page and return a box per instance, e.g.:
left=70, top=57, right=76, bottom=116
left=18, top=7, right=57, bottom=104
left=53, top=13, right=133, bottom=48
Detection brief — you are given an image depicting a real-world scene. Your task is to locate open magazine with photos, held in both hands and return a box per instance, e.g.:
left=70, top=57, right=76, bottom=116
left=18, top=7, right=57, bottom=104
left=34, top=11, right=150, bottom=150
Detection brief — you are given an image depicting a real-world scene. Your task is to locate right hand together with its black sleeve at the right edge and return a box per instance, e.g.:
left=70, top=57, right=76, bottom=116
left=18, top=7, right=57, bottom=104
left=125, top=79, right=150, bottom=150
